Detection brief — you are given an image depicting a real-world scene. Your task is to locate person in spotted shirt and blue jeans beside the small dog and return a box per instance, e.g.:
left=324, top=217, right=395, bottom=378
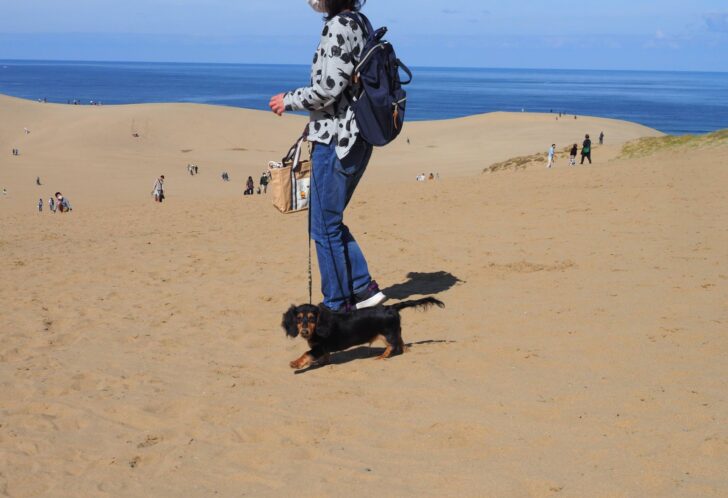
left=269, top=0, right=387, bottom=311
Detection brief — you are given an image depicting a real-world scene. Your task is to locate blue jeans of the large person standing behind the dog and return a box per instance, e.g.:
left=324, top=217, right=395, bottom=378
left=310, top=141, right=372, bottom=310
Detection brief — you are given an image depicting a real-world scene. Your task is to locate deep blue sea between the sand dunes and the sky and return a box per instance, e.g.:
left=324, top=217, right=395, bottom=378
left=0, top=61, right=728, bottom=134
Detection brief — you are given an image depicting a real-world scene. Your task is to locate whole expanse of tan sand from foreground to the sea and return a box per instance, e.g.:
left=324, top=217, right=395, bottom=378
left=0, top=97, right=728, bottom=497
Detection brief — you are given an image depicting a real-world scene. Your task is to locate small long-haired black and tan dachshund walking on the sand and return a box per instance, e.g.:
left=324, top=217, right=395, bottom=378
left=281, top=297, right=445, bottom=370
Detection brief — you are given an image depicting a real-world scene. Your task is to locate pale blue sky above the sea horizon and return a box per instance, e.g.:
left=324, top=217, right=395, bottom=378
left=0, top=0, right=728, bottom=71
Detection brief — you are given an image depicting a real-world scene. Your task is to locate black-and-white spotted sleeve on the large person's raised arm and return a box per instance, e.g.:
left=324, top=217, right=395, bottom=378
left=284, top=16, right=361, bottom=111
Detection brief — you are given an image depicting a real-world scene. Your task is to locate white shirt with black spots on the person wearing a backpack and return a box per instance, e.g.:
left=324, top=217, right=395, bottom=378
left=284, top=16, right=365, bottom=159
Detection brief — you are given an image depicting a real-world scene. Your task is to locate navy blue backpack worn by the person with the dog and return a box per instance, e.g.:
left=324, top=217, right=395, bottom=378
left=342, top=12, right=412, bottom=147
